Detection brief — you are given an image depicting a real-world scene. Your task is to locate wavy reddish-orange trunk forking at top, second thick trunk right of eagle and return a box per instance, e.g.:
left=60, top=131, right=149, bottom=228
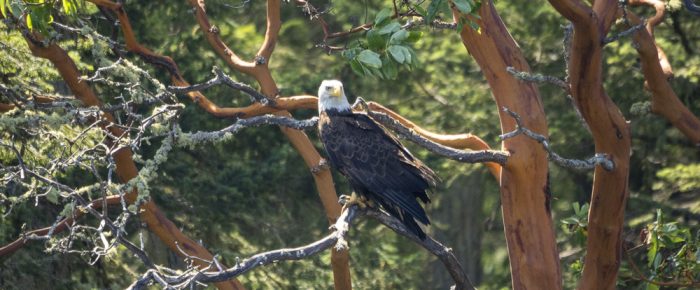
left=549, top=0, right=631, bottom=289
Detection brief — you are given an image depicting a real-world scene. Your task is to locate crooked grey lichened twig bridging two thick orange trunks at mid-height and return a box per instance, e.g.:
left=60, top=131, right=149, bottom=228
left=500, top=107, right=615, bottom=171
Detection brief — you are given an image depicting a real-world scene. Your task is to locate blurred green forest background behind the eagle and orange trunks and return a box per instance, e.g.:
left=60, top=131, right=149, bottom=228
left=0, top=0, right=700, bottom=289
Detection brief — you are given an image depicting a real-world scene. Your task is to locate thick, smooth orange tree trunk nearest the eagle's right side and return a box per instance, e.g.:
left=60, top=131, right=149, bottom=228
left=454, top=1, right=562, bottom=289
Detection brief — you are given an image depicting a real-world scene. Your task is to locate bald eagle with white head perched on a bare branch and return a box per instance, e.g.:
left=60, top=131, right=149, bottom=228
left=318, top=80, right=438, bottom=240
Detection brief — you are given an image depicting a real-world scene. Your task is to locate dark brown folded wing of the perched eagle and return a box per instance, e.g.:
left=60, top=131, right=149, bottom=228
left=321, top=114, right=437, bottom=227
